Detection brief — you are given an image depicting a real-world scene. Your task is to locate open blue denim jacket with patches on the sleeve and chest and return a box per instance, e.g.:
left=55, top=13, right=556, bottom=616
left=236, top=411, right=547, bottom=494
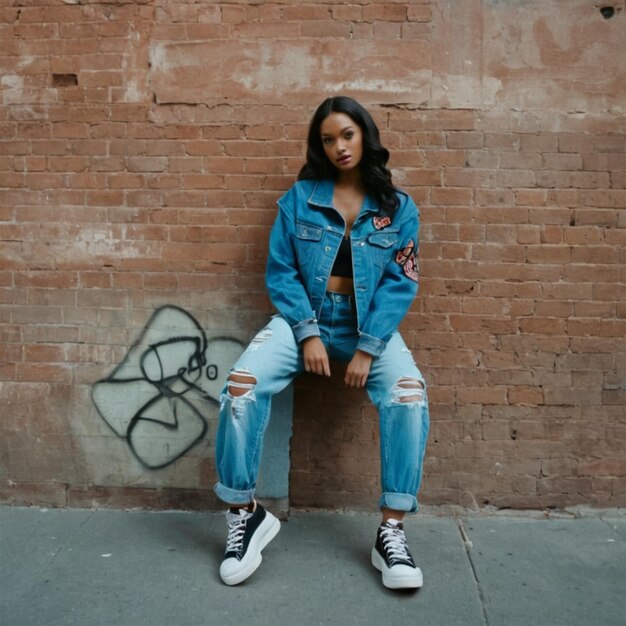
left=266, top=180, right=419, bottom=356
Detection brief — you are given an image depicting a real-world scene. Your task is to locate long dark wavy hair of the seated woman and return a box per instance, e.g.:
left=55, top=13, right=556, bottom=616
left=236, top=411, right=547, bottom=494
left=298, top=96, right=399, bottom=215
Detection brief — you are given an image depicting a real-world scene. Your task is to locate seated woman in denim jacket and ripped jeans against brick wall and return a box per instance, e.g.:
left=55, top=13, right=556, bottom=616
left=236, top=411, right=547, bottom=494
left=215, top=97, right=428, bottom=589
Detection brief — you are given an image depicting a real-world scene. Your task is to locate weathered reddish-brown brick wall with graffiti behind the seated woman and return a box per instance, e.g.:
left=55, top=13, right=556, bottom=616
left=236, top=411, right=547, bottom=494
left=0, top=0, right=626, bottom=508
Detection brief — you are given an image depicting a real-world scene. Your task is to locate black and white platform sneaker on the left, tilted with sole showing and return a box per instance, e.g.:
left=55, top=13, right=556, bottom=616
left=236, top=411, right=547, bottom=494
left=220, top=502, right=280, bottom=585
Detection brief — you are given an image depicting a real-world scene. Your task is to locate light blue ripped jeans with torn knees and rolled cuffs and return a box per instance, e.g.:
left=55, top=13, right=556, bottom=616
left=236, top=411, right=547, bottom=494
left=215, top=293, right=429, bottom=512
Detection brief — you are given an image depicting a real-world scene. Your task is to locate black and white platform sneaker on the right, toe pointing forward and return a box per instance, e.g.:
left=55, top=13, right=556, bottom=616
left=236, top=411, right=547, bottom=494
left=372, top=519, right=424, bottom=589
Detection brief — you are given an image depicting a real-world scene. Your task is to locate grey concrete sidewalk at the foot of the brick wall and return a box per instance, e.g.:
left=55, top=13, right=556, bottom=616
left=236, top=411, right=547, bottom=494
left=0, top=507, right=626, bottom=626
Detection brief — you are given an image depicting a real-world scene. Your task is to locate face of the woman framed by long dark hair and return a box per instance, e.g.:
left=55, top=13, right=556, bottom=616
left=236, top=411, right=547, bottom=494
left=320, top=113, right=363, bottom=172
